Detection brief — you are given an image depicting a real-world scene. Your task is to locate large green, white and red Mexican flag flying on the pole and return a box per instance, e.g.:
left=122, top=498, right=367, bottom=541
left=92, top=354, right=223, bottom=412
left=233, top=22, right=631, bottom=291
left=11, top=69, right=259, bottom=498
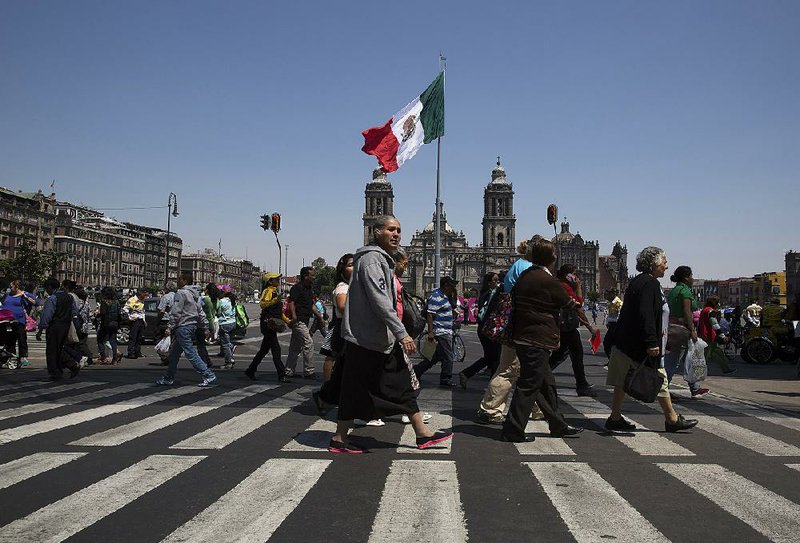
left=361, top=72, right=444, bottom=172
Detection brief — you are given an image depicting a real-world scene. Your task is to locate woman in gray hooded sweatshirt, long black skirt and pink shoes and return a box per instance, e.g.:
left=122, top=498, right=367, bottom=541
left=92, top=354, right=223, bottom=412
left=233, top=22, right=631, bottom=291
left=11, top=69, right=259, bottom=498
left=328, top=215, right=453, bottom=454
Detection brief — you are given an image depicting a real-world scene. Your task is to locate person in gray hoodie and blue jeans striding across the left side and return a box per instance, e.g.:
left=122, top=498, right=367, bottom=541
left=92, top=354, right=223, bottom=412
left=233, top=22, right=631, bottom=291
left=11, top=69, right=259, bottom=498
left=156, top=273, right=217, bottom=387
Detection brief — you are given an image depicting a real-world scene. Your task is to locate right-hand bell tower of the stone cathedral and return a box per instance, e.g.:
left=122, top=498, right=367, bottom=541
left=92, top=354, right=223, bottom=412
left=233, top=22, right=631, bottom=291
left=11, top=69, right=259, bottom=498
left=482, top=157, right=517, bottom=252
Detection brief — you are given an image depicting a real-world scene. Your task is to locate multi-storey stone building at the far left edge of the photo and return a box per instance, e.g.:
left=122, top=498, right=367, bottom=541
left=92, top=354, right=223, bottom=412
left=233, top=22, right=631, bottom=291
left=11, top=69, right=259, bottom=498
left=0, top=187, right=56, bottom=258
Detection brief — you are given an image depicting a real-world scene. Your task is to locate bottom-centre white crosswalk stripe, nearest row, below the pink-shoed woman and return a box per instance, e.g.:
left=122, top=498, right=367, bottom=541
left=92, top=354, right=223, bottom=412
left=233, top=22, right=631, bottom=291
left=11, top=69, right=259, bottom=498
left=369, top=460, right=467, bottom=543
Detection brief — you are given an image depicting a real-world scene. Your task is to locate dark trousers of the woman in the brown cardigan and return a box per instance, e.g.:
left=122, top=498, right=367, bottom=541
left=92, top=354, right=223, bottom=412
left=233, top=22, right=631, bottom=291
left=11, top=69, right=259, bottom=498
left=503, top=347, right=568, bottom=437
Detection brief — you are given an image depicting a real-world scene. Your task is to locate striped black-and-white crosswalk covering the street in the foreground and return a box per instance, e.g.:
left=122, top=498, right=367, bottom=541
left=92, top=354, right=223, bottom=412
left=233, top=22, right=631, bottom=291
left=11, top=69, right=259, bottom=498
left=0, top=379, right=800, bottom=543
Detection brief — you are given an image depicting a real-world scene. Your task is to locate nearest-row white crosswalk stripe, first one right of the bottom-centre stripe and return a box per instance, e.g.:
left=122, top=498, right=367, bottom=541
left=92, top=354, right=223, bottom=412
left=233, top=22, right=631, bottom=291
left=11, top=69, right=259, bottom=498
left=525, top=462, right=669, bottom=543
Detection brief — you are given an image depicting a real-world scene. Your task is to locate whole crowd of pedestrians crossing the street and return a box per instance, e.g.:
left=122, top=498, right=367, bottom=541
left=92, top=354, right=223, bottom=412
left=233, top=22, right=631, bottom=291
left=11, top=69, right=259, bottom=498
left=0, top=215, right=792, bottom=454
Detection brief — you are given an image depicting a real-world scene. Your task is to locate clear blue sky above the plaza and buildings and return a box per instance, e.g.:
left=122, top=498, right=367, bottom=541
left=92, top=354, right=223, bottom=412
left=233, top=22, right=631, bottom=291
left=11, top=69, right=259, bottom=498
left=0, top=0, right=800, bottom=278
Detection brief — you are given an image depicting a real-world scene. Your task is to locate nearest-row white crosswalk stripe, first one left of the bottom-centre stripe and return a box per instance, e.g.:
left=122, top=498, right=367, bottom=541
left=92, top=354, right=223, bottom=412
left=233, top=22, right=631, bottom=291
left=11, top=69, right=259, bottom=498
left=164, top=458, right=331, bottom=543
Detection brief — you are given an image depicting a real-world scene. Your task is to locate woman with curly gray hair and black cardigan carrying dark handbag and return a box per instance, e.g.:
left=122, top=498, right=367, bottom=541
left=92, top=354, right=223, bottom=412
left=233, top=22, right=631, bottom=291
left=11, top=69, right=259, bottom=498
left=605, top=247, right=697, bottom=432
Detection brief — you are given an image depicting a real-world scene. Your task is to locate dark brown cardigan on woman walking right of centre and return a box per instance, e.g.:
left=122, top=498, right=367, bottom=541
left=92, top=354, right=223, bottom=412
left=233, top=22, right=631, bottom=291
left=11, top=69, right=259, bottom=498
left=511, top=266, right=574, bottom=351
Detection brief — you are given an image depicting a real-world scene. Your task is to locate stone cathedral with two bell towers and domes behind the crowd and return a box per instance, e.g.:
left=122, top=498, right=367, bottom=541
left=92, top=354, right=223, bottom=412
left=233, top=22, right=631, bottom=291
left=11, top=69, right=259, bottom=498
left=363, top=158, right=628, bottom=296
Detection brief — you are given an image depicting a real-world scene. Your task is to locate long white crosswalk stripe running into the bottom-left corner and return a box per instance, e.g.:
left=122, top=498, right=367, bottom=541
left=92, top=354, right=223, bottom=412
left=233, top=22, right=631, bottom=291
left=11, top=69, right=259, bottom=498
left=0, top=455, right=205, bottom=543
